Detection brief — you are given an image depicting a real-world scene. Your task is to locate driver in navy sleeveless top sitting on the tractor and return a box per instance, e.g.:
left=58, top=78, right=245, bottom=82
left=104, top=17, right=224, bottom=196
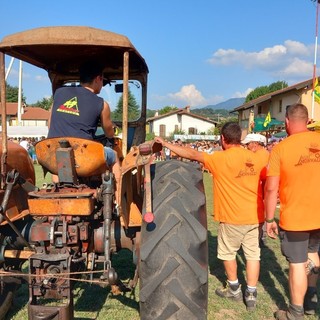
left=48, top=61, right=120, bottom=198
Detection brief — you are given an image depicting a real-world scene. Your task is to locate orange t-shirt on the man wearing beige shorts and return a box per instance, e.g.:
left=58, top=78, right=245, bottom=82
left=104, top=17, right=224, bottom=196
left=204, top=146, right=267, bottom=225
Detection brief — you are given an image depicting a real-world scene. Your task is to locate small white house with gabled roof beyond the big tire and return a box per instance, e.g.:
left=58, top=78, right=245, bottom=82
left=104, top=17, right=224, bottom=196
left=147, top=106, right=217, bottom=137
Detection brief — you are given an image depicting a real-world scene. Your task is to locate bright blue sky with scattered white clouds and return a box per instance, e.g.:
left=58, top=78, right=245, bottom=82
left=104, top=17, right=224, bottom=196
left=0, top=0, right=320, bottom=109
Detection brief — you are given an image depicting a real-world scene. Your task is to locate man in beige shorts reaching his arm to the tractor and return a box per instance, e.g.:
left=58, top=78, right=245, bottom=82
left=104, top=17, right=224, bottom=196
left=155, top=122, right=267, bottom=311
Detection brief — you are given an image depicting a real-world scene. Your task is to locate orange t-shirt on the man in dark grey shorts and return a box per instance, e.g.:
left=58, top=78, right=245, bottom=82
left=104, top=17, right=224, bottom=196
left=267, top=132, right=320, bottom=231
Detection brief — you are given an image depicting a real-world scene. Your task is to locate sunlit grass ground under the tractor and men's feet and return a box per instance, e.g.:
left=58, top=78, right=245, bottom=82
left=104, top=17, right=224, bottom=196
left=7, top=166, right=319, bottom=320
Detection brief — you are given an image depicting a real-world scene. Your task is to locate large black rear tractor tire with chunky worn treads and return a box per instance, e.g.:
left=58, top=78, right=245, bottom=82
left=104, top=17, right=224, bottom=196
left=139, top=160, right=208, bottom=320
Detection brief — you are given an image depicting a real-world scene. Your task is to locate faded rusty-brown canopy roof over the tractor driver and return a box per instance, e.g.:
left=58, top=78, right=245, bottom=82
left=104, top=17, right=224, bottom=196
left=0, top=26, right=148, bottom=87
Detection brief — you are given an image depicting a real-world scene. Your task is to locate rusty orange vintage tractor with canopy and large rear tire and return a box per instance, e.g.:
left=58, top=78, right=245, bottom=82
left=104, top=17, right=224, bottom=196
left=0, top=26, right=208, bottom=320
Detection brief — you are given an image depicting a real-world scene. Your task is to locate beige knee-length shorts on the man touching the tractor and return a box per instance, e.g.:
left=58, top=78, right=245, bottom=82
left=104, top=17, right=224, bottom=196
left=218, top=222, right=262, bottom=260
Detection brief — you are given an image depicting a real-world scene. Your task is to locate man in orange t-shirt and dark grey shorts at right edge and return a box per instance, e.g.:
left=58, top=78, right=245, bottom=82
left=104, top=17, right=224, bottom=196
left=265, top=104, right=320, bottom=319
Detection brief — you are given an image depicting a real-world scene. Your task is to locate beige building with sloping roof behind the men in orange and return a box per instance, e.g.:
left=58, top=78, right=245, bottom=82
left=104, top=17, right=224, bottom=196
left=232, top=79, right=320, bottom=132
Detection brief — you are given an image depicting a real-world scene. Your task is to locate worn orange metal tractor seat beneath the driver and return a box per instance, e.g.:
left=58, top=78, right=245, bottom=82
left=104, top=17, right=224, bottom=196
left=35, top=137, right=108, bottom=177
